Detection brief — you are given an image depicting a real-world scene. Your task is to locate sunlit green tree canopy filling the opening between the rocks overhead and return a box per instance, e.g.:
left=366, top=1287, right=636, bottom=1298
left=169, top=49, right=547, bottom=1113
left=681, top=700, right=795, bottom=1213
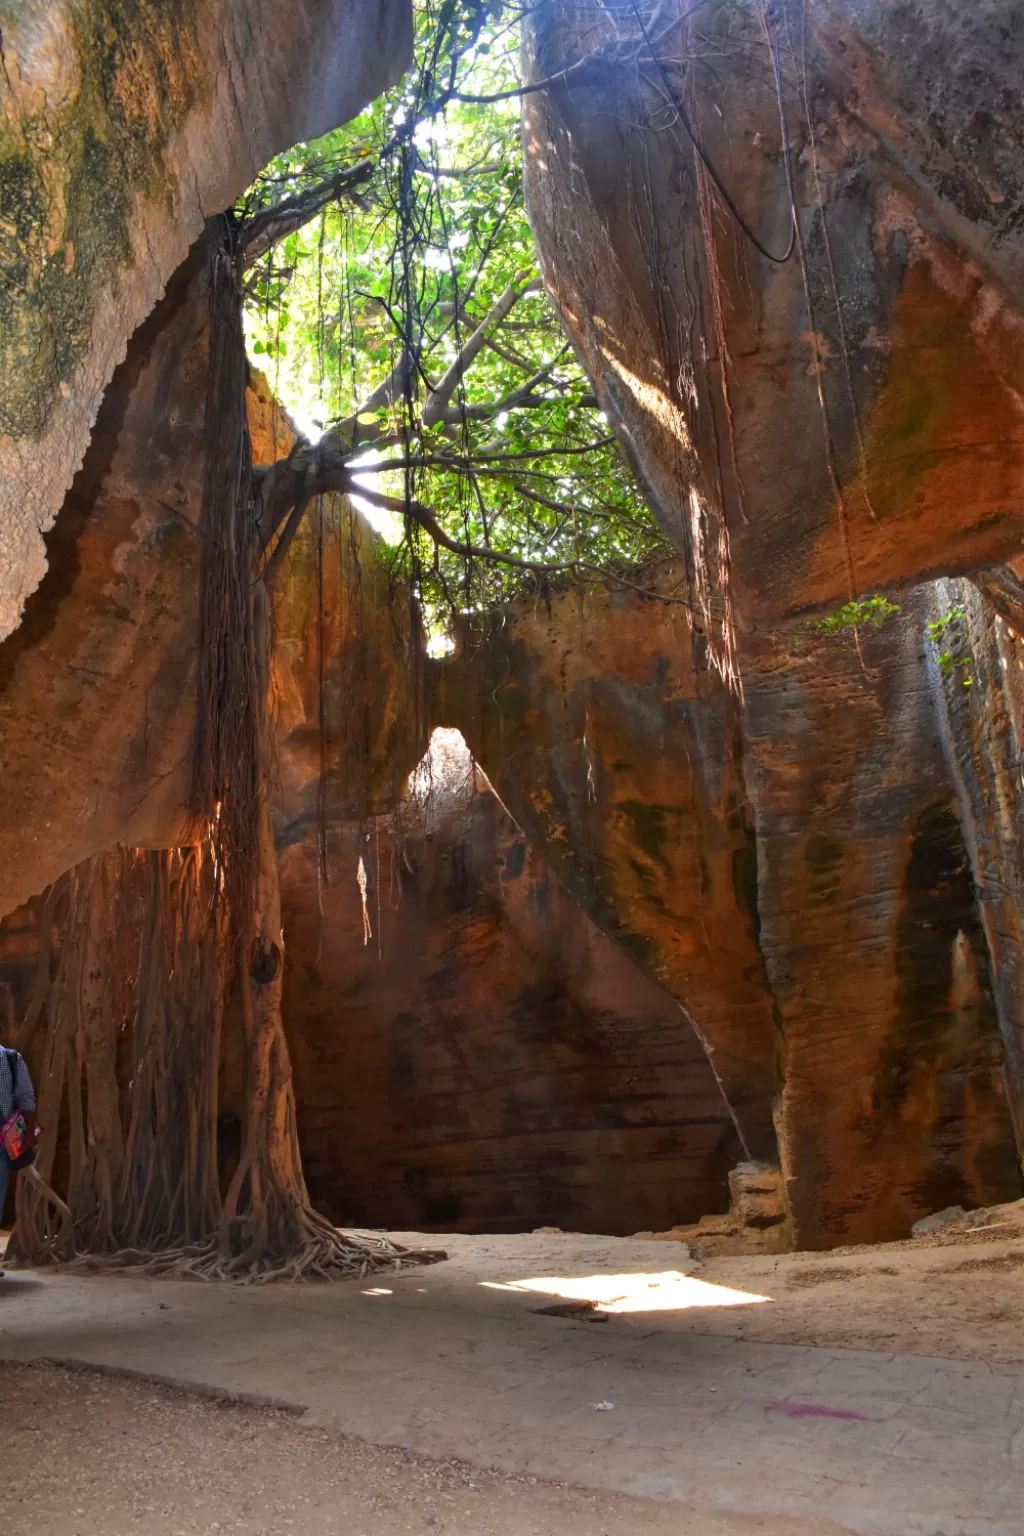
left=239, top=0, right=665, bottom=623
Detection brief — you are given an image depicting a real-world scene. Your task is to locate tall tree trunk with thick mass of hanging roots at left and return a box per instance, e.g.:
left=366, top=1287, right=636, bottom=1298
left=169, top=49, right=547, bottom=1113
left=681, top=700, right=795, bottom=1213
left=14, top=226, right=442, bottom=1276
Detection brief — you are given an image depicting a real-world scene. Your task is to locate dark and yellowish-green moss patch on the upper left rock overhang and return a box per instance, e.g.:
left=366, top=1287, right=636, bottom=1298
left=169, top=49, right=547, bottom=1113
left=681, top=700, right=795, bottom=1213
left=0, top=0, right=204, bottom=438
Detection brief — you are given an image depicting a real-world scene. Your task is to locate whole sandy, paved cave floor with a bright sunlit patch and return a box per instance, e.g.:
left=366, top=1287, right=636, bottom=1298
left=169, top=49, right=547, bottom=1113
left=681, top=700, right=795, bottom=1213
left=0, top=1233, right=1024, bottom=1536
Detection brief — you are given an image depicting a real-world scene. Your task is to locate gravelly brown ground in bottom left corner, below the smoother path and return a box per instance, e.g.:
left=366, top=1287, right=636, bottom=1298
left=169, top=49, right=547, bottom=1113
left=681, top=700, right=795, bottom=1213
left=0, top=1364, right=835, bottom=1536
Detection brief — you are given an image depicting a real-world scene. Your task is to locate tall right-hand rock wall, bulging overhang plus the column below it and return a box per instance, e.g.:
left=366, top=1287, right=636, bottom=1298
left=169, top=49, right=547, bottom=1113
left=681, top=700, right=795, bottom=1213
left=524, top=0, right=1024, bottom=1246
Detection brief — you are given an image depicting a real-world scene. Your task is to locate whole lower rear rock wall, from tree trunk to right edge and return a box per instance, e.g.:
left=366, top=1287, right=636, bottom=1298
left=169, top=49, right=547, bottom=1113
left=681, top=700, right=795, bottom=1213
left=8, top=571, right=1019, bottom=1247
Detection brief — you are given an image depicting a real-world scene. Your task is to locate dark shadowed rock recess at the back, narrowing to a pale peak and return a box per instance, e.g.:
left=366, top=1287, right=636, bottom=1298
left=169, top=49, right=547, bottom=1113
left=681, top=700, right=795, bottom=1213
left=281, top=733, right=740, bottom=1233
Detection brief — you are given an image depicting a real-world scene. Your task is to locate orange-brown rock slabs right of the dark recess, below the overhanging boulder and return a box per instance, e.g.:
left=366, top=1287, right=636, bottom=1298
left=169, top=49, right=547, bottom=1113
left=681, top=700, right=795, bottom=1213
left=434, top=588, right=1019, bottom=1247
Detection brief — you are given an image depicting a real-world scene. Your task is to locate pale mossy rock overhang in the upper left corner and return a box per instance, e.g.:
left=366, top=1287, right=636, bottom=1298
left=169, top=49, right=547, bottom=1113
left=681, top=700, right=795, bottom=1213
left=0, top=0, right=411, bottom=637
